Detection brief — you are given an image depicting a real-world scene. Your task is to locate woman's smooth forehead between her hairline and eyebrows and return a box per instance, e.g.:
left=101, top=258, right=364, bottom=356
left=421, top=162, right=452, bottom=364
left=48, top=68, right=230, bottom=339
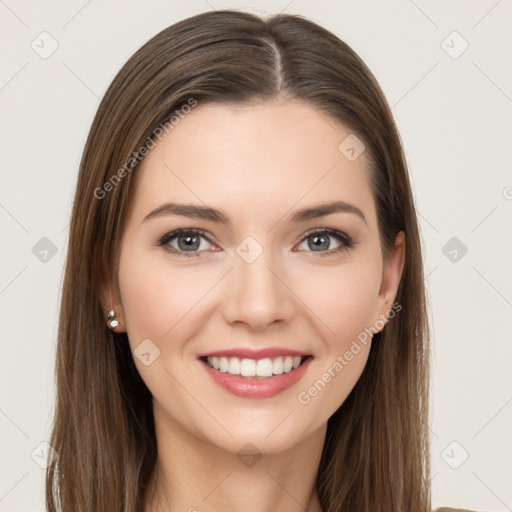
left=127, top=99, right=375, bottom=228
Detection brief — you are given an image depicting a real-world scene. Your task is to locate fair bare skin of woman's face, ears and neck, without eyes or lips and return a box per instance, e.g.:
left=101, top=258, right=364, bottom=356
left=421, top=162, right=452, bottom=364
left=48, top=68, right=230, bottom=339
left=102, top=98, right=405, bottom=512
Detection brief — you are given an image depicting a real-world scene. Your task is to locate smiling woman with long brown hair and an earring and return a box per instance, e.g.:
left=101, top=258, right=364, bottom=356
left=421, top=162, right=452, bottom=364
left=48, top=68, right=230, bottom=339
left=46, top=11, right=470, bottom=512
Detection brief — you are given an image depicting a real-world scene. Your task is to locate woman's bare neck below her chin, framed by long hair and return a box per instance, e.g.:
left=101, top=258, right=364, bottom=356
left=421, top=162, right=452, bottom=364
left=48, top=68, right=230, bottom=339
left=144, top=404, right=326, bottom=512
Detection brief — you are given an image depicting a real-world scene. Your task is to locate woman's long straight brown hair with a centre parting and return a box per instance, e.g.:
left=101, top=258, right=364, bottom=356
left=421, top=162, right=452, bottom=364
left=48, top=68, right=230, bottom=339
left=46, top=10, right=430, bottom=512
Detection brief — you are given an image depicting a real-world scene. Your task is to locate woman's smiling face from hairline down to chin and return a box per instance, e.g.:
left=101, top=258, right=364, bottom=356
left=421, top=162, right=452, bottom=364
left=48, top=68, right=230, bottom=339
left=109, top=99, right=403, bottom=453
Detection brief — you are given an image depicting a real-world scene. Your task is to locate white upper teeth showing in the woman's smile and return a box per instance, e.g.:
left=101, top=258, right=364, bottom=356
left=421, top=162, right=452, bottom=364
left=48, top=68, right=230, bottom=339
left=207, top=356, right=302, bottom=377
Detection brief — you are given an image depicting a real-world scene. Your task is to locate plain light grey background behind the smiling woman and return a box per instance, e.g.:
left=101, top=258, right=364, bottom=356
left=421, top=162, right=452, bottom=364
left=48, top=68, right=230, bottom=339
left=0, top=0, right=512, bottom=512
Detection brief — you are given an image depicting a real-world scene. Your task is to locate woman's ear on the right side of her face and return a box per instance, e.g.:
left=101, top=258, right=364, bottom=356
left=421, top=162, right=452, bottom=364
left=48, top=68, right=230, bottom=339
left=374, top=231, right=405, bottom=331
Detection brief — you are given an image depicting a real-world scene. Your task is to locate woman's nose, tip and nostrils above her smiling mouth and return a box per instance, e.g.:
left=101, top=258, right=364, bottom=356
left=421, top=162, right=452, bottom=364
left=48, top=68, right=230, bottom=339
left=224, top=251, right=295, bottom=331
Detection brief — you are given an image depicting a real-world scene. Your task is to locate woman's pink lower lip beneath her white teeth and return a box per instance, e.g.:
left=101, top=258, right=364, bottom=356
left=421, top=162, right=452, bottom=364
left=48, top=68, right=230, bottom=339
left=199, top=356, right=313, bottom=398
